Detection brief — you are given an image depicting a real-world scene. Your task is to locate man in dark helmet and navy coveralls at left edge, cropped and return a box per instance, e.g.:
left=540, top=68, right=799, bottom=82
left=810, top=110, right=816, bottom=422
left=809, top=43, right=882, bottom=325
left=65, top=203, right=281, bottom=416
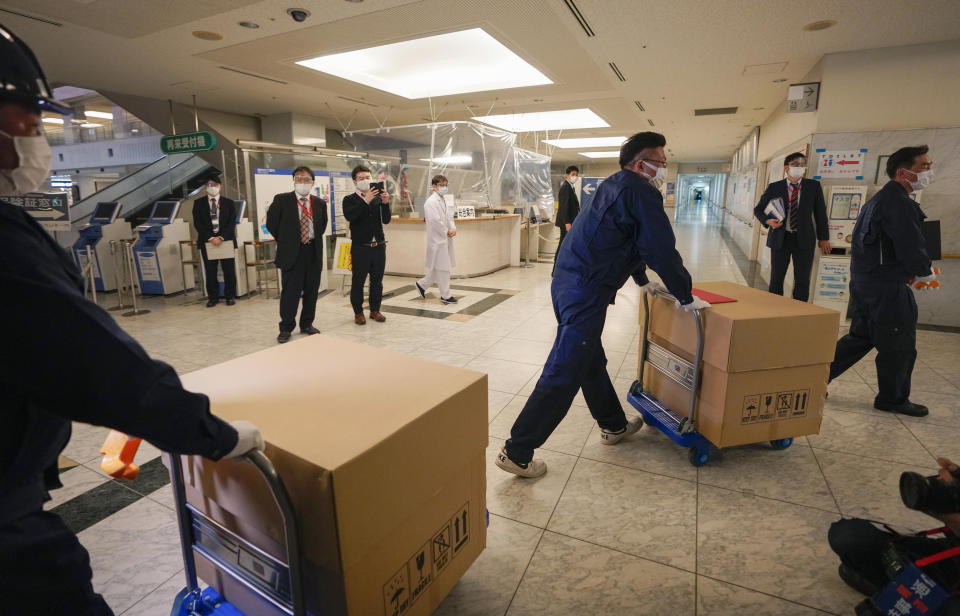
left=0, top=25, right=263, bottom=616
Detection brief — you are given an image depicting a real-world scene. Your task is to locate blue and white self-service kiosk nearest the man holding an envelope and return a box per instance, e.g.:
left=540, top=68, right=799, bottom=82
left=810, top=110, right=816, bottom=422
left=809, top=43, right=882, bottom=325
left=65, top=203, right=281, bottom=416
left=133, top=201, right=195, bottom=295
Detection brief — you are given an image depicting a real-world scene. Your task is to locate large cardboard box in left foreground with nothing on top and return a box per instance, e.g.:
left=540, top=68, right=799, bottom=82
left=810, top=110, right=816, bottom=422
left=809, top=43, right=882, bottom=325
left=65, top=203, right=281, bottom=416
left=183, top=335, right=487, bottom=616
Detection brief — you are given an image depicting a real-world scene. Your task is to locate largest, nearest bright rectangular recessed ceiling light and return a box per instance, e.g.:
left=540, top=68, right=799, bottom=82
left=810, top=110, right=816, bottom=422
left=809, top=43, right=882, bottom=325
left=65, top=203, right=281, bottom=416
left=297, top=28, right=553, bottom=99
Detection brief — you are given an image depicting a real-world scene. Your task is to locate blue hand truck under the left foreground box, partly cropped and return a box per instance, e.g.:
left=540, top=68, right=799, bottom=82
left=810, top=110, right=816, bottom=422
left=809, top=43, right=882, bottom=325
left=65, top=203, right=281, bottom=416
left=170, top=450, right=307, bottom=616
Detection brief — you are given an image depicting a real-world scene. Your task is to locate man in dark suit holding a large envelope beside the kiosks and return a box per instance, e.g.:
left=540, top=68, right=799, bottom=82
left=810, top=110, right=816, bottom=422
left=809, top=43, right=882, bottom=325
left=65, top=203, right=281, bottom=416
left=193, top=173, right=237, bottom=308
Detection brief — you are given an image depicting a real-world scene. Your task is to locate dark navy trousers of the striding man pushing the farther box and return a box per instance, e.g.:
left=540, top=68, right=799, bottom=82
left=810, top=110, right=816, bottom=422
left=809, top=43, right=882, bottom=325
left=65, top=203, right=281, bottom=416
left=507, top=299, right=627, bottom=464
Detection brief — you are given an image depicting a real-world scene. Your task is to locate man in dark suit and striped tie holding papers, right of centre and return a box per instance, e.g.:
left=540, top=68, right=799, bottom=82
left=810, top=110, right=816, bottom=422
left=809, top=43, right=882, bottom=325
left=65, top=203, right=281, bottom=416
left=753, top=152, right=830, bottom=302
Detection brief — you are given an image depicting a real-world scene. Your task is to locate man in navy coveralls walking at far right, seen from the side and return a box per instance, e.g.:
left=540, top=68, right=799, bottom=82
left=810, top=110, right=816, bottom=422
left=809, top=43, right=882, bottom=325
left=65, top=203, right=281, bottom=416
left=830, top=145, right=937, bottom=417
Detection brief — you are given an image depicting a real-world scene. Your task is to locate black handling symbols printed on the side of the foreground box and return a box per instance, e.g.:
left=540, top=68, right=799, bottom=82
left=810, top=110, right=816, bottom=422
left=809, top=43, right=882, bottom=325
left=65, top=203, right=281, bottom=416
left=383, top=503, right=471, bottom=616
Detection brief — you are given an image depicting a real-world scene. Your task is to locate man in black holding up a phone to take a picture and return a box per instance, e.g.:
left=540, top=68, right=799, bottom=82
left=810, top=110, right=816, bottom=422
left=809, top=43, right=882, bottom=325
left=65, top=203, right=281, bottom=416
left=343, top=165, right=390, bottom=325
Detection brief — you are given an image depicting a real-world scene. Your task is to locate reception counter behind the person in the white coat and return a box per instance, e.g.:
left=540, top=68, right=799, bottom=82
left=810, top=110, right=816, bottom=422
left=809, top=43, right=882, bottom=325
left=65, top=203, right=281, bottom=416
left=383, top=214, right=520, bottom=278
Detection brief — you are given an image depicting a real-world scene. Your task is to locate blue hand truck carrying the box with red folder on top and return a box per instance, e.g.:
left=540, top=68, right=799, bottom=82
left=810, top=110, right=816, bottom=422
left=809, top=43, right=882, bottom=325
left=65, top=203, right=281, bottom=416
left=627, top=289, right=793, bottom=466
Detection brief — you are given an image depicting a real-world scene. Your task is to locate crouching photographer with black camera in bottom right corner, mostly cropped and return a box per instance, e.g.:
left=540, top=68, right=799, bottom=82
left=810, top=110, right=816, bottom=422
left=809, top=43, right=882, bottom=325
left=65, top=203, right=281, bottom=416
left=827, top=458, right=960, bottom=616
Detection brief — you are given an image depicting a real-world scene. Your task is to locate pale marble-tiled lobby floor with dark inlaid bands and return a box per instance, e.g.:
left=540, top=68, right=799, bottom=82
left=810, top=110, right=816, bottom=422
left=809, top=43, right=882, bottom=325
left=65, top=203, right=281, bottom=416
left=50, top=203, right=960, bottom=616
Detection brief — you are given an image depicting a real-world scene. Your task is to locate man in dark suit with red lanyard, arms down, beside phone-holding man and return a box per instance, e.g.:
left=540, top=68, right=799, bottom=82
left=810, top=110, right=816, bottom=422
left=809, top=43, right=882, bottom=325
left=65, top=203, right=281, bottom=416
left=267, top=167, right=327, bottom=344
